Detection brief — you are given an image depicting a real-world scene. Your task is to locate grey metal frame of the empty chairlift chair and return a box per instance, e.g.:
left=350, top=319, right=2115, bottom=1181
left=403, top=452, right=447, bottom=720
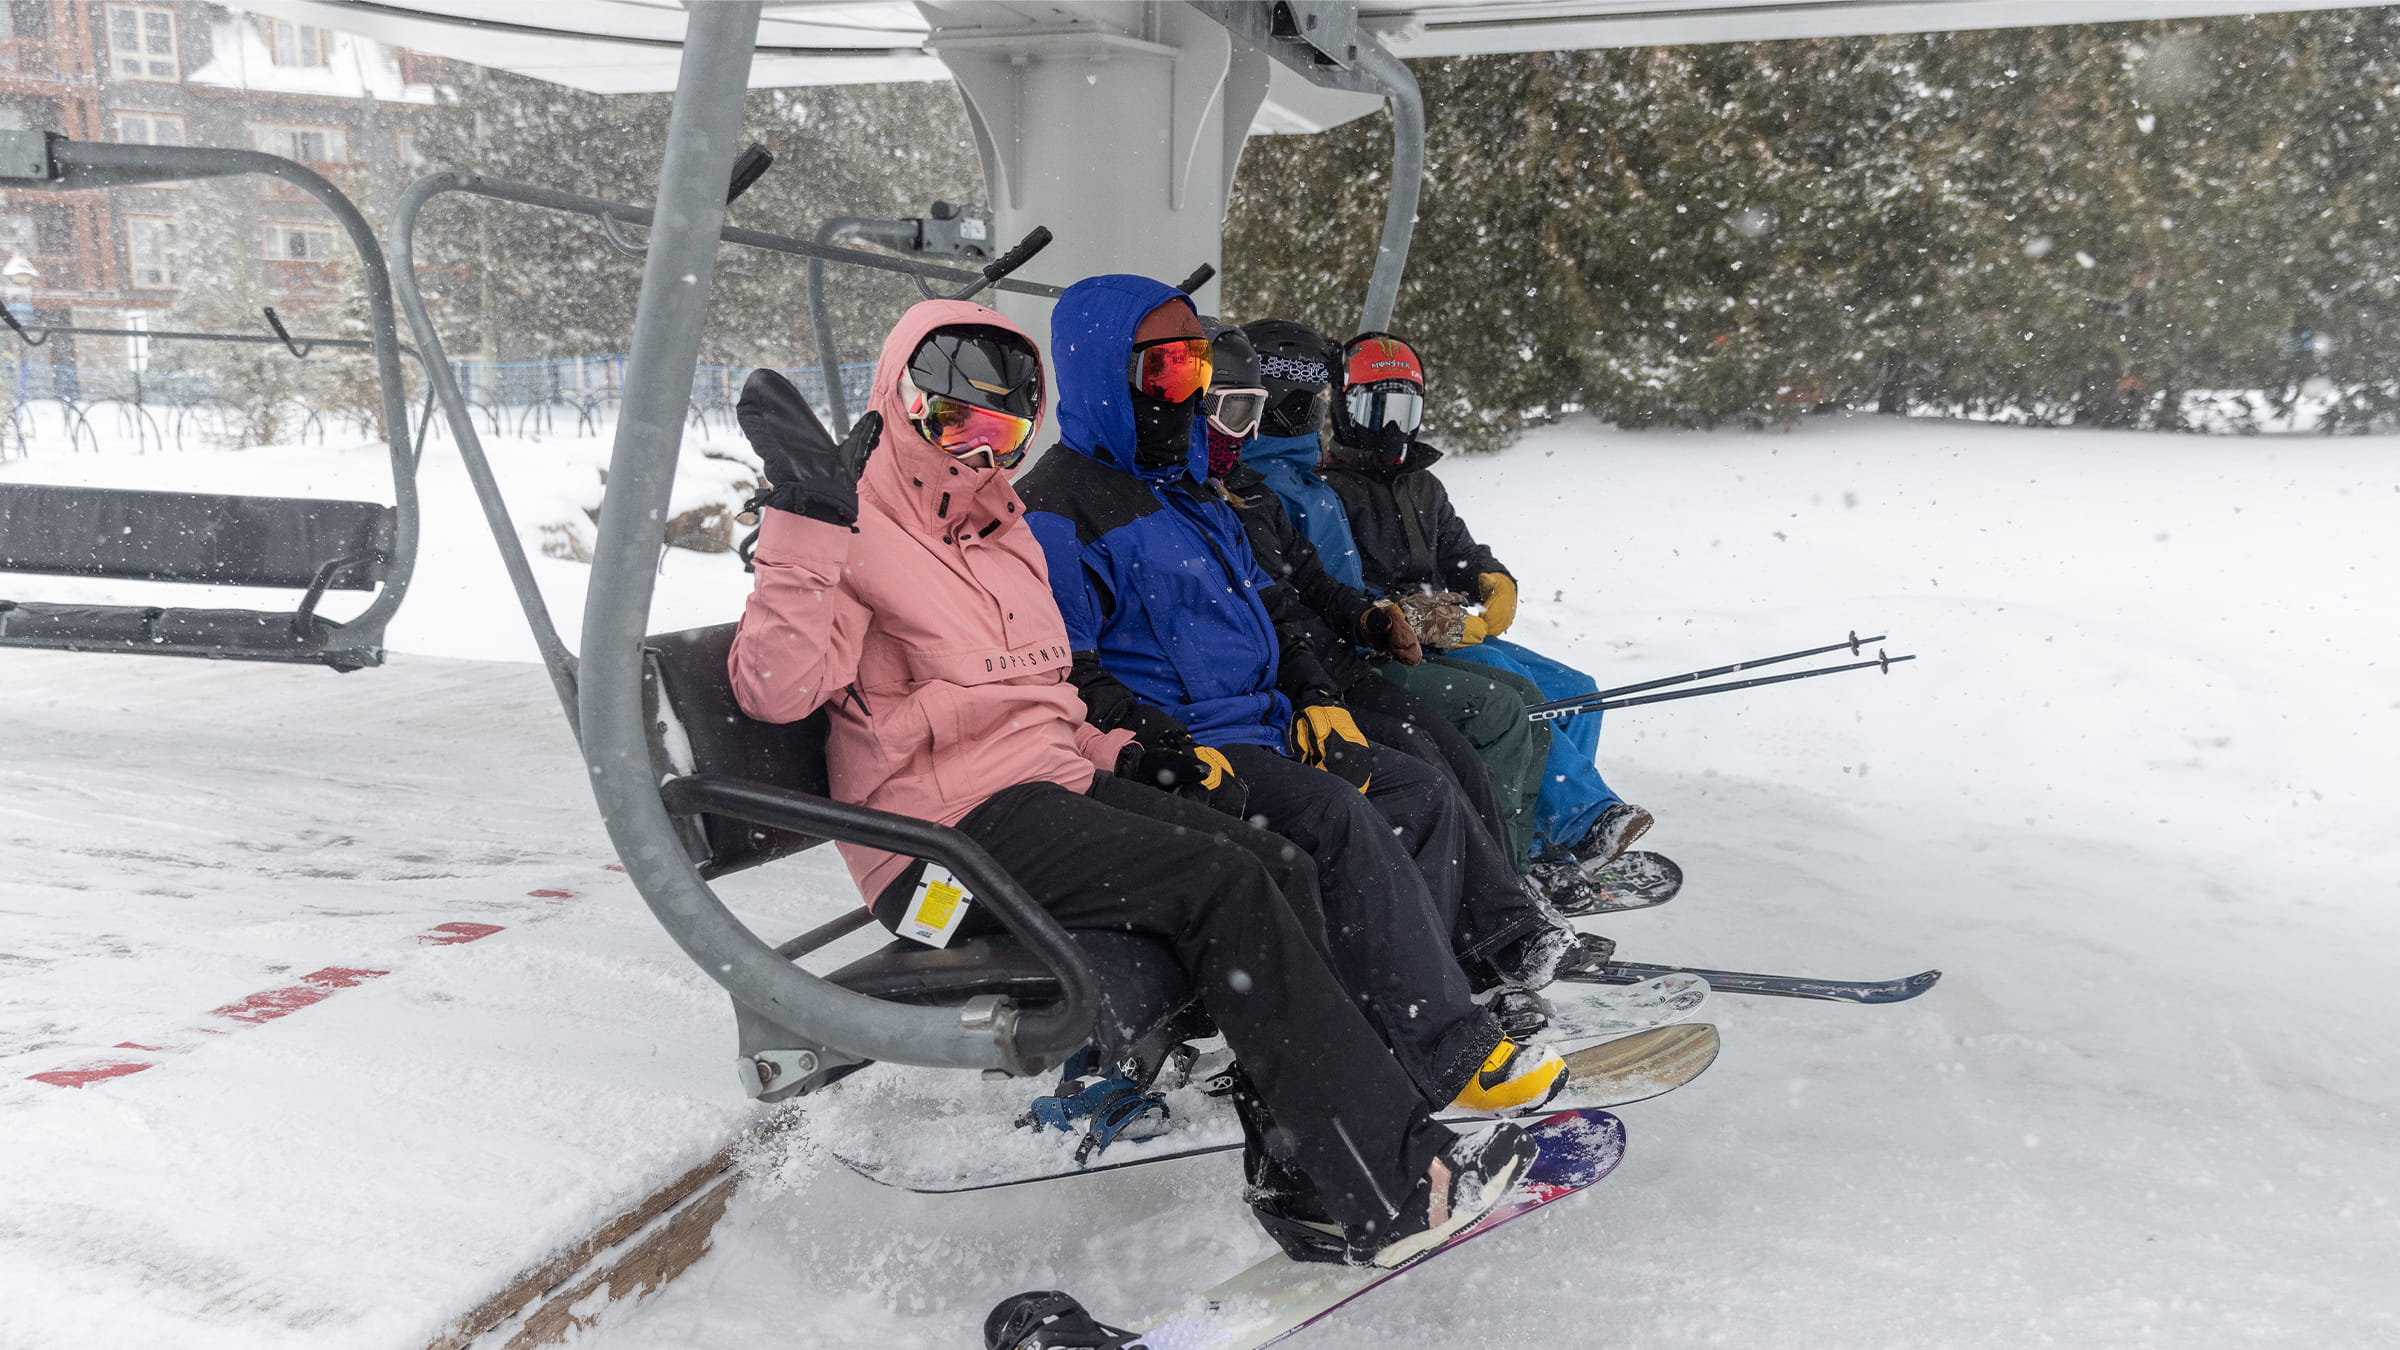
left=0, top=132, right=418, bottom=670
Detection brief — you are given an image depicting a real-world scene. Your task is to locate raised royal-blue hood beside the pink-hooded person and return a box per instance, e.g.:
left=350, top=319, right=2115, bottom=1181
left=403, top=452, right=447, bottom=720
left=1051, top=271, right=1207, bottom=480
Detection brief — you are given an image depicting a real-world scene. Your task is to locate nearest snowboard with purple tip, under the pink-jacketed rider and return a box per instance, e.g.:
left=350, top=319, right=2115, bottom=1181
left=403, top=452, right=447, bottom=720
left=1036, top=1110, right=1625, bottom=1350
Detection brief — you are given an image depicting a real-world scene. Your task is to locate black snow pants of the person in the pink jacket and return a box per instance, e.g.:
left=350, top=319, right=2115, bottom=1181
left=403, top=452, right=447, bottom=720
left=876, top=769, right=1452, bottom=1227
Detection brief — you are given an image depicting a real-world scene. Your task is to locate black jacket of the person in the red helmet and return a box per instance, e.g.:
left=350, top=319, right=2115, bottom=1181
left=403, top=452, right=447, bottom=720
left=1320, top=442, right=1507, bottom=598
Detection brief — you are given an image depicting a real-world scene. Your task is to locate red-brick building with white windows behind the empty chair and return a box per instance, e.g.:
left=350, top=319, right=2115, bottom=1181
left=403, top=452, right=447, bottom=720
left=0, top=0, right=439, bottom=368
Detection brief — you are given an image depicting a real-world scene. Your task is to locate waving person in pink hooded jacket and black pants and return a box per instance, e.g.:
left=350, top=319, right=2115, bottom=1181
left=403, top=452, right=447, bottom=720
left=732, top=300, right=1531, bottom=1264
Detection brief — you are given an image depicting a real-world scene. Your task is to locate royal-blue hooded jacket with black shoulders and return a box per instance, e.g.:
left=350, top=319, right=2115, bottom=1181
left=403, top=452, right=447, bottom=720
left=1018, top=276, right=1291, bottom=749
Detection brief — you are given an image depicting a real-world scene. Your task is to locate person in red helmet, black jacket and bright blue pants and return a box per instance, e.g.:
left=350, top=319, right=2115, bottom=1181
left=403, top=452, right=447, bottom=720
left=1325, top=334, right=1651, bottom=870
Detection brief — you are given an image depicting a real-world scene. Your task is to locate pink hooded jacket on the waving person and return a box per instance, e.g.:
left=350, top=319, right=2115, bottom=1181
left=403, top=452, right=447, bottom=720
left=732, top=300, right=1133, bottom=903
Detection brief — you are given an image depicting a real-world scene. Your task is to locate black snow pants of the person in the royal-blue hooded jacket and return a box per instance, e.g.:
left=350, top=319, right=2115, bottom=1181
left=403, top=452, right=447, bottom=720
left=1219, top=745, right=1548, bottom=1105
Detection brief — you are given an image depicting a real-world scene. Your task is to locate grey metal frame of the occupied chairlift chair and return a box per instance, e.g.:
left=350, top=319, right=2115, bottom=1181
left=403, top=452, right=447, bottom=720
left=391, top=0, right=1423, bottom=1080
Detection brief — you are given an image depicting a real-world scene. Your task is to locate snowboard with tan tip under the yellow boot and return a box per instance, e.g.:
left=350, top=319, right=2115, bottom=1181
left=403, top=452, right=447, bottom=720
left=828, top=1023, right=1718, bottom=1196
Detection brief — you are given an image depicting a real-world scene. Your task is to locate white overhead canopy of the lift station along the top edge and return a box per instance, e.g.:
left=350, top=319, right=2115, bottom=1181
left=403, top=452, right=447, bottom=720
left=220, top=0, right=2359, bottom=94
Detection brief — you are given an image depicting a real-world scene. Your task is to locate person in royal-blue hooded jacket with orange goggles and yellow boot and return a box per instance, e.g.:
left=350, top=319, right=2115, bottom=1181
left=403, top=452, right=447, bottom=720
left=1018, top=276, right=1574, bottom=1110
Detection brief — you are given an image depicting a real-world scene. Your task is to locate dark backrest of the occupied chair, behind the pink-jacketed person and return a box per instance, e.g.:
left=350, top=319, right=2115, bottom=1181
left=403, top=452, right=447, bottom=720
left=643, top=625, right=828, bottom=879
